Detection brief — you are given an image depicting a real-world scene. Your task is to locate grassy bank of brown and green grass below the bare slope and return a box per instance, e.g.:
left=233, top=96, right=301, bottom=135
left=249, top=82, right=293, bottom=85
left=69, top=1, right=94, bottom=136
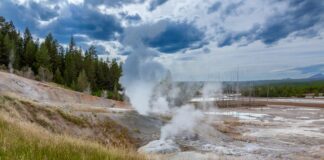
left=0, top=96, right=146, bottom=160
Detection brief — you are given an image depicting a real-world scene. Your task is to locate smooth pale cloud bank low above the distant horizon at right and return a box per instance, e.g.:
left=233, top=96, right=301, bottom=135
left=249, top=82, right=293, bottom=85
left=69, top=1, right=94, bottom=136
left=159, top=31, right=324, bottom=80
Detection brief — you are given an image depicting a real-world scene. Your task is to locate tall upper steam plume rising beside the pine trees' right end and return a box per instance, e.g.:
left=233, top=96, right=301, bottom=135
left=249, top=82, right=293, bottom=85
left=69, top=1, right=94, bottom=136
left=121, top=20, right=167, bottom=115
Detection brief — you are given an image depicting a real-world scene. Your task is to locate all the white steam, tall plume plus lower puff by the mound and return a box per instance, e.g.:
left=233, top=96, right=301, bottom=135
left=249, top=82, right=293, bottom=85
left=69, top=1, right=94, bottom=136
left=121, top=23, right=219, bottom=145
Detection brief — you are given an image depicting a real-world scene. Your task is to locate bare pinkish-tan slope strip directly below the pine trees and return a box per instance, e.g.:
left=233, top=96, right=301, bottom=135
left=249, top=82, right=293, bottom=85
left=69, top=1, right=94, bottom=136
left=0, top=72, right=127, bottom=108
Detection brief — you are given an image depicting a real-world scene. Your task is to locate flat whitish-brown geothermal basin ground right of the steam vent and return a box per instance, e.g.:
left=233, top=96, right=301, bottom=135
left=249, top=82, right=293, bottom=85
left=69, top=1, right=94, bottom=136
left=132, top=100, right=324, bottom=160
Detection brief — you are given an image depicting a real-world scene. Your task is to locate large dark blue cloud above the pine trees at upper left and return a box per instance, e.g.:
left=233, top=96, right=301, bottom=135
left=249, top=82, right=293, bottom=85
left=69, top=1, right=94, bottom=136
left=0, top=0, right=123, bottom=43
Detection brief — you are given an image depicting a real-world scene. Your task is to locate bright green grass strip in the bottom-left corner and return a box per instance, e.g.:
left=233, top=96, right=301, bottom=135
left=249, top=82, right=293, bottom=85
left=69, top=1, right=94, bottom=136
left=0, top=116, right=145, bottom=160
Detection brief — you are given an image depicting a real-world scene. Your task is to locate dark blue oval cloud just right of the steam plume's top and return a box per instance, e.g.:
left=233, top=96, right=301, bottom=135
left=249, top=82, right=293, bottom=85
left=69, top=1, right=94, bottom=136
left=144, top=22, right=205, bottom=53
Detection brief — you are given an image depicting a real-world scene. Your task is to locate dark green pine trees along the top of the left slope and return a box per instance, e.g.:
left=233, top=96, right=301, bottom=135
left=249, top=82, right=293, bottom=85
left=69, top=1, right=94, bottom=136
left=0, top=16, right=122, bottom=100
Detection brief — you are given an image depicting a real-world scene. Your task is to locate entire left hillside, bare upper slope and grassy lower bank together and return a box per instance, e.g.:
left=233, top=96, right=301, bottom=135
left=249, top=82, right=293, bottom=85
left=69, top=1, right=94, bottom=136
left=0, top=72, right=149, bottom=159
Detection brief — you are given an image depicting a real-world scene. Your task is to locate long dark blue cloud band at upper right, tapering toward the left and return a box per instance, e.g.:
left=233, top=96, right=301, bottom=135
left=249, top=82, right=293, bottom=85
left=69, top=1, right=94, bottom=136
left=218, top=0, right=324, bottom=47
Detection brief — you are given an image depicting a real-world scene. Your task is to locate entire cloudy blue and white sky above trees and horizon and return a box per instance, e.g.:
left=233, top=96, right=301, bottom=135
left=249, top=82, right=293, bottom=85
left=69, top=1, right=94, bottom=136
left=0, top=0, right=324, bottom=80
